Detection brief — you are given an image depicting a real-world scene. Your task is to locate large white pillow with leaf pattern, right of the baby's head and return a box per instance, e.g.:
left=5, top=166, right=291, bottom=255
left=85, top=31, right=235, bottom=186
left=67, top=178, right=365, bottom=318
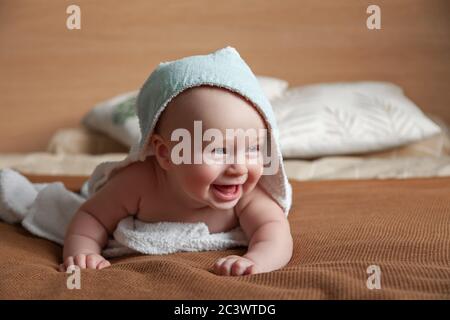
left=272, top=81, right=440, bottom=158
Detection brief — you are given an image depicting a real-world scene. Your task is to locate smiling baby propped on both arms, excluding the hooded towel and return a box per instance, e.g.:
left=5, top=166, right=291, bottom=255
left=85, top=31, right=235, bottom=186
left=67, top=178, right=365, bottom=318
left=60, top=48, right=293, bottom=276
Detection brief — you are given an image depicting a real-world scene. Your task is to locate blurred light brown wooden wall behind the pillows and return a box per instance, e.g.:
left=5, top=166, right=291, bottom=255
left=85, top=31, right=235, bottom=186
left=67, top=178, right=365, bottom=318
left=0, top=0, right=450, bottom=152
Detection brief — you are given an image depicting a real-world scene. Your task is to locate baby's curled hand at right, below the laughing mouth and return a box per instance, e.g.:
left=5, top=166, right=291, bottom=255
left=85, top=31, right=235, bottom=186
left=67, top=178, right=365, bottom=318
left=214, top=255, right=261, bottom=276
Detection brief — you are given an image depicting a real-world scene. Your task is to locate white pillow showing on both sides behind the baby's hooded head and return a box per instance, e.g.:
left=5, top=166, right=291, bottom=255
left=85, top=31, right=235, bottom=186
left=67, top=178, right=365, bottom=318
left=82, top=76, right=288, bottom=147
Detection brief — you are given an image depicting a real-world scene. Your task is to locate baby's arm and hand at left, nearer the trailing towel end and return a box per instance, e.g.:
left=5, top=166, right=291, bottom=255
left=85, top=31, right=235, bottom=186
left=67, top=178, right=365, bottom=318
left=60, top=165, right=142, bottom=271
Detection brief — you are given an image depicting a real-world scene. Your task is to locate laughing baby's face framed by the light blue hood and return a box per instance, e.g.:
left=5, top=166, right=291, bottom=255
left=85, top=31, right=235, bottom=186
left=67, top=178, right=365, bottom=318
left=154, top=86, right=266, bottom=209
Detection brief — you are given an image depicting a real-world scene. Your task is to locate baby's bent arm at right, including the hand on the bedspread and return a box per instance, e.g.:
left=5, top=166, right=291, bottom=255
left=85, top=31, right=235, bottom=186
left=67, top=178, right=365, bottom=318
left=214, top=187, right=293, bottom=275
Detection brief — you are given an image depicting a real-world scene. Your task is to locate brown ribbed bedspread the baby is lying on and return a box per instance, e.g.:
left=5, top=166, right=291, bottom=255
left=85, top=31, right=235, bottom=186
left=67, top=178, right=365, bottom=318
left=0, top=178, right=450, bottom=299
